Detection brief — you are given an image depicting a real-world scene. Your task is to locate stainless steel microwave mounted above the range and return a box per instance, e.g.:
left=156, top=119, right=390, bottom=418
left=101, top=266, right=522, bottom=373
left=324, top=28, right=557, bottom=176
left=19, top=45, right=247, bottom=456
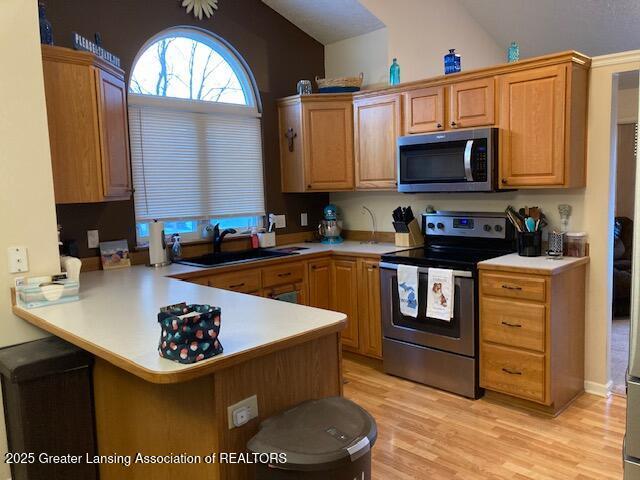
left=398, top=128, right=498, bottom=193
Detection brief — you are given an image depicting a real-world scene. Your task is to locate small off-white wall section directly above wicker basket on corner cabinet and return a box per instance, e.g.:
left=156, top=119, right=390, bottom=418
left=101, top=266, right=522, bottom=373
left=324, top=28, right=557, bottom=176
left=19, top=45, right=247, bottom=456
left=324, top=28, right=389, bottom=87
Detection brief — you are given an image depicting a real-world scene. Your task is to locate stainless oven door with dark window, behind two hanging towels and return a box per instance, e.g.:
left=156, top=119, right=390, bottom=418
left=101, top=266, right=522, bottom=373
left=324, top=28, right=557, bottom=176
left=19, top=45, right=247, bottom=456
left=380, top=262, right=477, bottom=357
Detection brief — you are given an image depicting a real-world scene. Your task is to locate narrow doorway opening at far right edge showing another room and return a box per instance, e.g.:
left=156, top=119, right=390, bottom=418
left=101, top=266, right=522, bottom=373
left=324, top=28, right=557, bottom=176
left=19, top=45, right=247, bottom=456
left=610, top=71, right=639, bottom=395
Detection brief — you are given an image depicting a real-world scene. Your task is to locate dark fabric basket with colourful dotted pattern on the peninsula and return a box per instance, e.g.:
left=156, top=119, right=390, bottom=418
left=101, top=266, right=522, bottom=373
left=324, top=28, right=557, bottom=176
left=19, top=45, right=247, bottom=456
left=158, top=304, right=222, bottom=363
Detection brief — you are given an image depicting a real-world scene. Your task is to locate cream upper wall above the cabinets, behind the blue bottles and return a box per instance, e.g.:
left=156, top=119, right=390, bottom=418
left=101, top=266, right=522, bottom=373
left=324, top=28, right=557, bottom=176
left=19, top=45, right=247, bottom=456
left=325, top=0, right=508, bottom=84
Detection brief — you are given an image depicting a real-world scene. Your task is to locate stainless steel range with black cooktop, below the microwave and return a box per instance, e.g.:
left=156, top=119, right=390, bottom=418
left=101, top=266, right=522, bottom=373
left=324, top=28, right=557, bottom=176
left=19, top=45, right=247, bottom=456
left=380, top=212, right=515, bottom=398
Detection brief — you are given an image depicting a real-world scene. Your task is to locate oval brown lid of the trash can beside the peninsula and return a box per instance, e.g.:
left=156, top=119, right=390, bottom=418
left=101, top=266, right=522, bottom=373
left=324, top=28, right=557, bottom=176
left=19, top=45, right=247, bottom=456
left=248, top=397, right=378, bottom=471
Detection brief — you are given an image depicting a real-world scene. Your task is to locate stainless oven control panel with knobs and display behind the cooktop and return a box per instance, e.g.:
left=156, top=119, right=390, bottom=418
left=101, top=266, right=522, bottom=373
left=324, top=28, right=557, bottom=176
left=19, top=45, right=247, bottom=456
left=422, top=212, right=510, bottom=240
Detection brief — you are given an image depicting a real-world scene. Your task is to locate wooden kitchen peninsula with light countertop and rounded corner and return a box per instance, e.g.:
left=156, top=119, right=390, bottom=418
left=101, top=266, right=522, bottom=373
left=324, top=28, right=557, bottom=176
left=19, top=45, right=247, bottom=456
left=13, top=265, right=346, bottom=480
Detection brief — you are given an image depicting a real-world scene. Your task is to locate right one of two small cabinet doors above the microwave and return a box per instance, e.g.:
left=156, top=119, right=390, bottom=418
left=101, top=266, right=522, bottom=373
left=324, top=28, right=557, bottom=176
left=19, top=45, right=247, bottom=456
left=449, top=77, right=495, bottom=128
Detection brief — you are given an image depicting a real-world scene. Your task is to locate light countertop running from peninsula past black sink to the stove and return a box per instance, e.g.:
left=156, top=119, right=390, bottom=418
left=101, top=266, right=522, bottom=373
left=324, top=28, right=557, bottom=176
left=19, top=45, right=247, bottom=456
left=14, top=241, right=399, bottom=383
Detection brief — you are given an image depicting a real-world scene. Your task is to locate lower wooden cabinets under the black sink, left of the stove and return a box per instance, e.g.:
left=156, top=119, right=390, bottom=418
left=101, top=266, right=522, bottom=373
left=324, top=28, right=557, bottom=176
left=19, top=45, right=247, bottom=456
left=178, top=255, right=382, bottom=358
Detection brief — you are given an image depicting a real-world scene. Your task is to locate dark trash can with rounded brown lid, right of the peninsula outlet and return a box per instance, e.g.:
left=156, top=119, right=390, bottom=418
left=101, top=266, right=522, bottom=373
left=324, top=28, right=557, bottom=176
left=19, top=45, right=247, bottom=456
left=248, top=397, right=378, bottom=480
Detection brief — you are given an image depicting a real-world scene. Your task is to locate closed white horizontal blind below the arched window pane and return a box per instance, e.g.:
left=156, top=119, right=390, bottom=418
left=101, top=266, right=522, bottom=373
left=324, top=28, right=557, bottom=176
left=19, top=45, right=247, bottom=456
left=129, top=99, right=265, bottom=222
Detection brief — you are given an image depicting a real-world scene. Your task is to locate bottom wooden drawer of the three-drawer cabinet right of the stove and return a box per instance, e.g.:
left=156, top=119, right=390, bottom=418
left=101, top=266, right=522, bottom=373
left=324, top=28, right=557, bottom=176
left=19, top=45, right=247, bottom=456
left=480, top=343, right=545, bottom=403
